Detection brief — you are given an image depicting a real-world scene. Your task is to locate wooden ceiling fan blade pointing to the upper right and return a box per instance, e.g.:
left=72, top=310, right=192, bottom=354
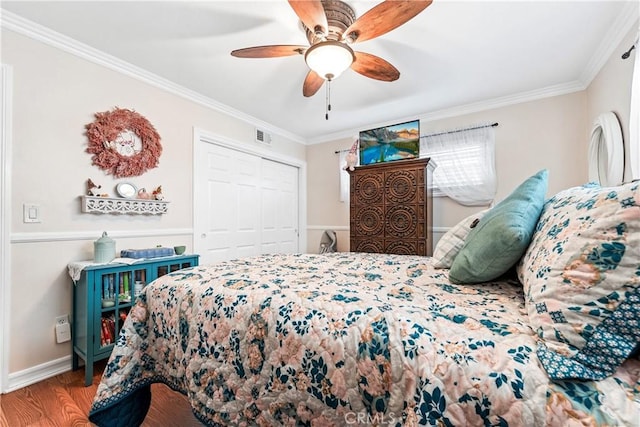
left=344, top=0, right=432, bottom=43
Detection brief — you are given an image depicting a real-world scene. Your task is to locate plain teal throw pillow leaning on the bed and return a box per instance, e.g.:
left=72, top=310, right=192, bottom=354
left=449, top=169, right=549, bottom=284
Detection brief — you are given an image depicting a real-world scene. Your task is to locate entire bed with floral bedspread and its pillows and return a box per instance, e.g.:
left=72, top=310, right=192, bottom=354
left=90, top=174, right=640, bottom=426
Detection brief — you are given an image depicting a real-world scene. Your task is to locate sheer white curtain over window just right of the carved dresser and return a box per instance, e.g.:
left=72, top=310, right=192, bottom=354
left=420, top=125, right=496, bottom=206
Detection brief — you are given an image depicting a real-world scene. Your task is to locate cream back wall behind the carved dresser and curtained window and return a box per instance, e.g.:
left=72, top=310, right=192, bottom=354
left=307, top=91, right=587, bottom=251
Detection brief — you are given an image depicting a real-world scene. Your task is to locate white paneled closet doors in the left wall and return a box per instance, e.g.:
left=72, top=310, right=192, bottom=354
left=194, top=141, right=299, bottom=264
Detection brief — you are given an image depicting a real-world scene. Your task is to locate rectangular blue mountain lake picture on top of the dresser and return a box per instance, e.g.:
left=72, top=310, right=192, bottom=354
left=360, top=120, right=420, bottom=165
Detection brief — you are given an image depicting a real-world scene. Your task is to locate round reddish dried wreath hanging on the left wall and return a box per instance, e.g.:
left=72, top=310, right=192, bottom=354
left=85, top=108, right=162, bottom=178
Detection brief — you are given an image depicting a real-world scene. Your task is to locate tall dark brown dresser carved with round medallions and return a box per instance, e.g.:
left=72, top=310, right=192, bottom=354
left=349, top=158, right=434, bottom=256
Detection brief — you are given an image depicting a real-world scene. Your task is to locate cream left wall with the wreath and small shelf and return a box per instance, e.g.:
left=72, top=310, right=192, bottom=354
left=2, top=29, right=306, bottom=388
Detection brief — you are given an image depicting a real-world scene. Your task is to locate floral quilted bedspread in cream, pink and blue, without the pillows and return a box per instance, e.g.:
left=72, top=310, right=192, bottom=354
left=90, top=253, right=640, bottom=426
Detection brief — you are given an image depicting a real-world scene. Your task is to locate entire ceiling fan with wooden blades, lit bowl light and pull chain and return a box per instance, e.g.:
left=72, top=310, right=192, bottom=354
left=231, top=0, right=432, bottom=113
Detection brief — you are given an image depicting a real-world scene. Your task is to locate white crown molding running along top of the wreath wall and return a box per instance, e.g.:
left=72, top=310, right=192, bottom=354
left=0, top=9, right=306, bottom=144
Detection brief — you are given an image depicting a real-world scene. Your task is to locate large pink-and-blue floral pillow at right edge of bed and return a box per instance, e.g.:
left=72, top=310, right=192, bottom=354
left=517, top=182, right=640, bottom=378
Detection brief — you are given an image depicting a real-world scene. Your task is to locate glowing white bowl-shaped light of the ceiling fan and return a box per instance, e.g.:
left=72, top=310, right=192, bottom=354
left=304, top=40, right=356, bottom=80
